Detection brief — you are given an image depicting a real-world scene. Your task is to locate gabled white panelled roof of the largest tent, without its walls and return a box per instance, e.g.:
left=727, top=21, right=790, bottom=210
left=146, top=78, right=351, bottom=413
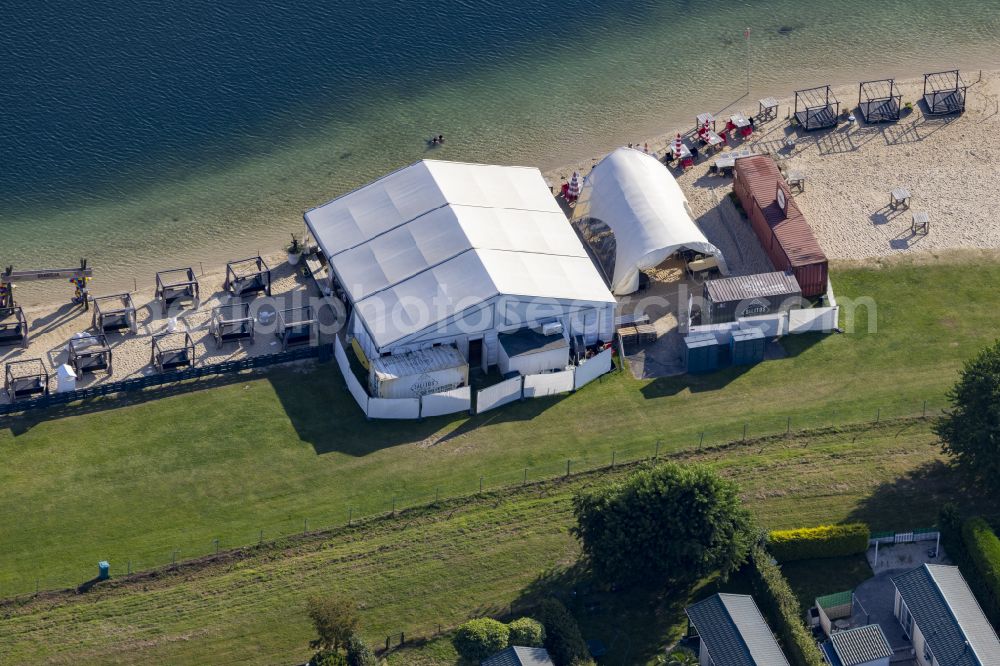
left=305, top=160, right=614, bottom=348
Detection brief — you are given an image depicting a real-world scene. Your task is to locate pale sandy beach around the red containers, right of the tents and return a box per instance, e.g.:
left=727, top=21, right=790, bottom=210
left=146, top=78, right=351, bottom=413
left=546, top=71, right=1000, bottom=265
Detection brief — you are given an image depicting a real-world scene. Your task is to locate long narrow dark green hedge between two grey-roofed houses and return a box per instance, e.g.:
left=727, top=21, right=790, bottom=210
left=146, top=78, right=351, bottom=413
left=748, top=546, right=826, bottom=666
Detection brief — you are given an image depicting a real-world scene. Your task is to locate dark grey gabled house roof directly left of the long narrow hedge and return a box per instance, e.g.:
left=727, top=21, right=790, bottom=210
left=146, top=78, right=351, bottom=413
left=686, top=594, right=788, bottom=666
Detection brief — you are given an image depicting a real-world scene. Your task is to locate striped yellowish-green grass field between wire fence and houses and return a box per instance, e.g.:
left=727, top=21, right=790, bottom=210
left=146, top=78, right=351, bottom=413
left=0, top=419, right=992, bottom=665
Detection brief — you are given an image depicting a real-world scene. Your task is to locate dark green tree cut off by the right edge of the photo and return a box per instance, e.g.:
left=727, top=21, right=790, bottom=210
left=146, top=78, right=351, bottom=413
left=934, top=340, right=1000, bottom=480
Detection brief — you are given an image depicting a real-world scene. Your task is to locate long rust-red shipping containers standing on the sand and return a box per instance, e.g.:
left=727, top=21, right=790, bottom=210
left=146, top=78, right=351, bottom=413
left=733, top=155, right=829, bottom=298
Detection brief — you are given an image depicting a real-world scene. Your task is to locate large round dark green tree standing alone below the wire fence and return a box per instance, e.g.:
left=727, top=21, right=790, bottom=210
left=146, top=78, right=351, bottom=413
left=573, top=463, right=755, bottom=585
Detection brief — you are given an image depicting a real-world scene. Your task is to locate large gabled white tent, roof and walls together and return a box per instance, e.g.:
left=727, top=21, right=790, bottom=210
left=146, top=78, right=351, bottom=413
left=305, top=160, right=615, bottom=368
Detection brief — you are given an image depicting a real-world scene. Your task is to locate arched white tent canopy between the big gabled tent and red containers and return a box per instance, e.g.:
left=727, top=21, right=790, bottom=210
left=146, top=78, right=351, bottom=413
left=575, top=148, right=729, bottom=294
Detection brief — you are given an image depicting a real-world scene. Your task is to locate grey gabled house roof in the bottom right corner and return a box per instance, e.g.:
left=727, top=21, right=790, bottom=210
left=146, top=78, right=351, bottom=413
left=892, top=564, right=1000, bottom=666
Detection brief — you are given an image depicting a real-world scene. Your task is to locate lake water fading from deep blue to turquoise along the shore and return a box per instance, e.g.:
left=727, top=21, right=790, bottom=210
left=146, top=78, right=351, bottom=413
left=0, top=0, right=1000, bottom=302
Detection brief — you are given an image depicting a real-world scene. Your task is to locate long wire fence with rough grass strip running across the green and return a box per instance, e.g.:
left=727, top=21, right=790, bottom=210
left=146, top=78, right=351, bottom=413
left=0, top=397, right=947, bottom=599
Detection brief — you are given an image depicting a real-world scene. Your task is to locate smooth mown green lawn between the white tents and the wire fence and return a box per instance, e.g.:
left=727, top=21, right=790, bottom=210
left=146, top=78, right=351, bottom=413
left=0, top=253, right=1000, bottom=597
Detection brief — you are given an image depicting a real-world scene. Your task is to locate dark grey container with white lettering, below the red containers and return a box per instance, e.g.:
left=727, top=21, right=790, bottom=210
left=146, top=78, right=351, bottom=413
left=701, top=271, right=802, bottom=324
